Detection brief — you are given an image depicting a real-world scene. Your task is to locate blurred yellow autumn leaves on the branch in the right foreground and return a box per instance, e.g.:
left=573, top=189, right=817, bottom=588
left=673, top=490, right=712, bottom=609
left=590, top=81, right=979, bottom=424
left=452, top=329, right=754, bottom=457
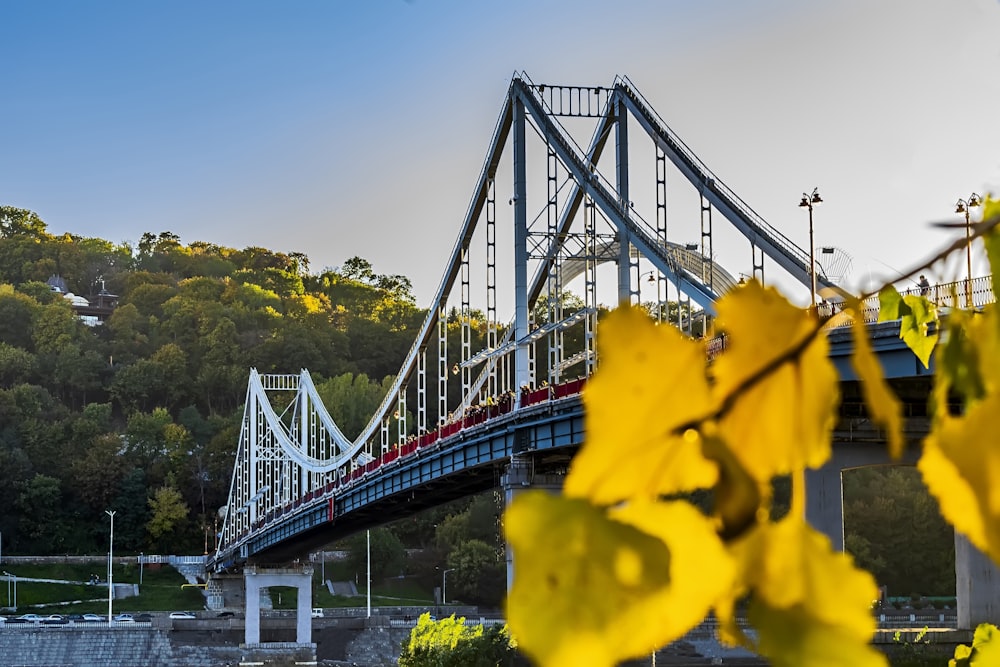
left=506, top=200, right=1000, bottom=666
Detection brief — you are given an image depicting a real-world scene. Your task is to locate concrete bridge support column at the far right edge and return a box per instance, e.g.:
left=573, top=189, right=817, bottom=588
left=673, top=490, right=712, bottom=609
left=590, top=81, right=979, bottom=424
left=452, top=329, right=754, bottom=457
left=955, top=533, right=1000, bottom=630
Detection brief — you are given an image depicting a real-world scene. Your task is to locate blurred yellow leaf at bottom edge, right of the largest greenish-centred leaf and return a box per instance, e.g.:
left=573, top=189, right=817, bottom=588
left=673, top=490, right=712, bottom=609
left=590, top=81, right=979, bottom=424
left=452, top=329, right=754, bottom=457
left=720, top=515, right=886, bottom=667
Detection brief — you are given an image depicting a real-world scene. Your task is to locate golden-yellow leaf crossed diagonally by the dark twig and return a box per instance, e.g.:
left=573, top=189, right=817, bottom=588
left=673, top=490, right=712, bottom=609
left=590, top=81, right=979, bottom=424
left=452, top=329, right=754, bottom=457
left=713, top=281, right=839, bottom=482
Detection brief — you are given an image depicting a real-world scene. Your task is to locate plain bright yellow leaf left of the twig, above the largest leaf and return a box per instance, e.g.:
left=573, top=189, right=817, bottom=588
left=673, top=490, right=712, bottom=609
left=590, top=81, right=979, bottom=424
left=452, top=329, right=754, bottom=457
left=564, top=308, right=717, bottom=505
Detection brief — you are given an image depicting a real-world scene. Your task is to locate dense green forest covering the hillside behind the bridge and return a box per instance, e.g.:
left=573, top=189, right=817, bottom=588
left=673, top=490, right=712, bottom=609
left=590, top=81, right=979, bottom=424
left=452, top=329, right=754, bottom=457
left=0, top=206, right=954, bottom=597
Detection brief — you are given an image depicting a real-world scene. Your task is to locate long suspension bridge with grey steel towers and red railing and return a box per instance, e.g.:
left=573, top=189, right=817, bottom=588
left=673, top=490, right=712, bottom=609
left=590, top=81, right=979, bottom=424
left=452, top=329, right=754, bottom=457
left=210, top=73, right=992, bottom=643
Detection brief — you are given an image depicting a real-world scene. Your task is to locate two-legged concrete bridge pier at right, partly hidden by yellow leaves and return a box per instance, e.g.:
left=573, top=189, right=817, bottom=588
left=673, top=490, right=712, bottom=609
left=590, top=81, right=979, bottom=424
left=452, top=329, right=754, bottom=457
left=806, top=442, right=1000, bottom=630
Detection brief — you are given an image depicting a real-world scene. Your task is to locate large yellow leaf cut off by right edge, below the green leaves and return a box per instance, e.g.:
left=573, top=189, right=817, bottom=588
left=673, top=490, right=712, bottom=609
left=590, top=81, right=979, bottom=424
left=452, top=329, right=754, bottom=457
left=917, top=392, right=1000, bottom=563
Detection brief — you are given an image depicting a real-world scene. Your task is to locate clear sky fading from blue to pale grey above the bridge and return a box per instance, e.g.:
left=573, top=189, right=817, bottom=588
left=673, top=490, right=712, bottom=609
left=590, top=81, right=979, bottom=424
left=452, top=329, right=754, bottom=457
left=0, top=0, right=1000, bottom=305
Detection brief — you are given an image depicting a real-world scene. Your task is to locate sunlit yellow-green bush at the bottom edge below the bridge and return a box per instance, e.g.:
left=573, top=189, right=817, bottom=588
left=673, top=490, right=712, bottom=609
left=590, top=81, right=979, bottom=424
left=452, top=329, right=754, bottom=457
left=399, top=613, right=515, bottom=667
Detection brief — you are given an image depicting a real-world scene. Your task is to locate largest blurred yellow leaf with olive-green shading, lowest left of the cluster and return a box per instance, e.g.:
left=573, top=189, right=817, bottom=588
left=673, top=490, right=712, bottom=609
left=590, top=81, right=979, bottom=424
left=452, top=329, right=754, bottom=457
left=505, top=491, right=734, bottom=667
